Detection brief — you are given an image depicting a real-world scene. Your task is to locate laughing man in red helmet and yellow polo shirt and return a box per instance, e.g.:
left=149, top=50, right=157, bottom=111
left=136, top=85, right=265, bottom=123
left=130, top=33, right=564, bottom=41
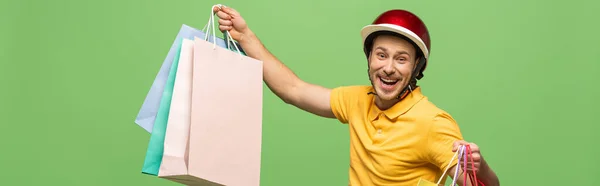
left=214, top=7, right=499, bottom=186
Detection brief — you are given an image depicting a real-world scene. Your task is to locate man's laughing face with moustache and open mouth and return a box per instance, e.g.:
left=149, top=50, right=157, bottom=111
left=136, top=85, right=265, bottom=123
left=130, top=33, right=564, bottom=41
left=369, top=35, right=416, bottom=101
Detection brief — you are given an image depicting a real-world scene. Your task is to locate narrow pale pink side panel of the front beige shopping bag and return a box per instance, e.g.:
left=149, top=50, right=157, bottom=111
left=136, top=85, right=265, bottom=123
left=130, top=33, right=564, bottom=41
left=158, top=38, right=194, bottom=177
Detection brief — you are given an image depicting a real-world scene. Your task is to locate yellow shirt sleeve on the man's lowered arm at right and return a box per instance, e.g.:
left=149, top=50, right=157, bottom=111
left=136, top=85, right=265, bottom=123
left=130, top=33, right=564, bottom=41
left=427, top=113, right=463, bottom=170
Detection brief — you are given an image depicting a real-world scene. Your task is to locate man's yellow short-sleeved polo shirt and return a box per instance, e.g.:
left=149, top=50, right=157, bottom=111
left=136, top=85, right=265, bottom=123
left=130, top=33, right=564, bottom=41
left=331, top=86, right=463, bottom=186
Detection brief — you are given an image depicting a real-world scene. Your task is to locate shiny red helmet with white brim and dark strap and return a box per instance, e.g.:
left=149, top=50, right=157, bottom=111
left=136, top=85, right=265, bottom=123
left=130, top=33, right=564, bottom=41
left=361, top=10, right=431, bottom=79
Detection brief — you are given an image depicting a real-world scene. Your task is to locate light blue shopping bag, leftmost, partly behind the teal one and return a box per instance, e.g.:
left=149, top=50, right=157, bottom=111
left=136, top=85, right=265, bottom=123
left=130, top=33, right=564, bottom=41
left=135, top=24, right=246, bottom=133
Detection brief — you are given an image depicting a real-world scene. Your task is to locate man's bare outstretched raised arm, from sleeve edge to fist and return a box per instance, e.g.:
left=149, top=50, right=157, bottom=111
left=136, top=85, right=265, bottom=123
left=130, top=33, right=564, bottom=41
left=214, top=7, right=335, bottom=118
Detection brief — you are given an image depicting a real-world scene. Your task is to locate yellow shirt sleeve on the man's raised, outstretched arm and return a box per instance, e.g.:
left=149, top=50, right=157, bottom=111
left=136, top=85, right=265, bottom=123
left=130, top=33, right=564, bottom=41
left=330, top=87, right=354, bottom=124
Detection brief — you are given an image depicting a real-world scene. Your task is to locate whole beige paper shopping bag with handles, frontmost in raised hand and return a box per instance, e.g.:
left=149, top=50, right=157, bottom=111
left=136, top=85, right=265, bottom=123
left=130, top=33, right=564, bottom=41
left=159, top=5, right=263, bottom=186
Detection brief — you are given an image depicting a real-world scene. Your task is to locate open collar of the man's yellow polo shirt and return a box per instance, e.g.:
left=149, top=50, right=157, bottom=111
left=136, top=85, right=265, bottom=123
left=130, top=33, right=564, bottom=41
left=369, top=87, right=425, bottom=121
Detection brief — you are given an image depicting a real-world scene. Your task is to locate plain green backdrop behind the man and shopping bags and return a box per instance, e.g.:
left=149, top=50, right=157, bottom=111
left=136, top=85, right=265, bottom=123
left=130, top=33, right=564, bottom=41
left=0, top=0, right=600, bottom=186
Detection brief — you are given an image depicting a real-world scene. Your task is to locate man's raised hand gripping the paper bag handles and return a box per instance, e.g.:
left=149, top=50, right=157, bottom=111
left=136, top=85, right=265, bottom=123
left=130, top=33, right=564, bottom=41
left=213, top=6, right=250, bottom=42
